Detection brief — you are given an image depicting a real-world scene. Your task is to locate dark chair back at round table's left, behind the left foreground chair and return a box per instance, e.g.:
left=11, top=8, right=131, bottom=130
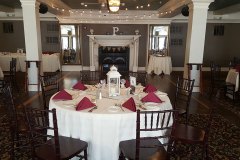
left=39, top=72, right=59, bottom=109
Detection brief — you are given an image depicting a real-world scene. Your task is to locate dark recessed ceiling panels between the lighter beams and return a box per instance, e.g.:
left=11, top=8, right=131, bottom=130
left=0, top=0, right=240, bottom=11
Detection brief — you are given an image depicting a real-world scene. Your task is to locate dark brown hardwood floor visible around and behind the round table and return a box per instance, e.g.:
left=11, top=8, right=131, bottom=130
left=18, top=72, right=240, bottom=127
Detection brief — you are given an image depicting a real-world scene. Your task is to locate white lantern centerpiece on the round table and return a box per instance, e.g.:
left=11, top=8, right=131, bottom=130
left=107, top=65, right=121, bottom=97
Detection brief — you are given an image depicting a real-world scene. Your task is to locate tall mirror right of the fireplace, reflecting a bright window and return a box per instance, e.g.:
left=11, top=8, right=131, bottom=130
left=149, top=26, right=169, bottom=52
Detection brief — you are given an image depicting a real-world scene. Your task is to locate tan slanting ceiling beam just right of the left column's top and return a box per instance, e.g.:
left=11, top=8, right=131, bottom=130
left=38, top=0, right=71, bottom=16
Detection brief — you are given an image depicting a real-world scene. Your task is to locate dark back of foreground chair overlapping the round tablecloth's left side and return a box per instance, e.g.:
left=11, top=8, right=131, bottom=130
left=25, top=108, right=60, bottom=159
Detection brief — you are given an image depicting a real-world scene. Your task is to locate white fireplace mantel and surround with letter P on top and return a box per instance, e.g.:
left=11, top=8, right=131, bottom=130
left=88, top=35, right=141, bottom=72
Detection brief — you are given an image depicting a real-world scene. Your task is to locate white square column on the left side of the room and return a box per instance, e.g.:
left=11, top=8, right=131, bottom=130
left=20, top=0, right=42, bottom=91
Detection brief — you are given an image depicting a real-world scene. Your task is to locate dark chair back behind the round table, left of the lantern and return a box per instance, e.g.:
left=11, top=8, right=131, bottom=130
left=80, top=71, right=103, bottom=85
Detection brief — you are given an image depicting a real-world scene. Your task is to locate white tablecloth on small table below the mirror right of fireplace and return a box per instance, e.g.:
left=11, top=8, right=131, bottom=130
left=147, top=55, right=172, bottom=75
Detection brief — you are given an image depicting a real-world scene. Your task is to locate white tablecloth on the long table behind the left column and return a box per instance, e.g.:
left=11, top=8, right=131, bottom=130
left=0, top=52, right=61, bottom=72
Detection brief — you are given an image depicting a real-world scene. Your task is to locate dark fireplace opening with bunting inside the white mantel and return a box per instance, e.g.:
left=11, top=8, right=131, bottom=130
left=98, top=46, right=129, bottom=72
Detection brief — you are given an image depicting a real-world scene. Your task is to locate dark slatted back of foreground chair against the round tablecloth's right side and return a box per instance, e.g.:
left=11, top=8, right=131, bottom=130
left=135, top=110, right=178, bottom=160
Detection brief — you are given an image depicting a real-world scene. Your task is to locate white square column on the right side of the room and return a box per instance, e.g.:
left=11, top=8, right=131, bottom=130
left=184, top=0, right=213, bottom=92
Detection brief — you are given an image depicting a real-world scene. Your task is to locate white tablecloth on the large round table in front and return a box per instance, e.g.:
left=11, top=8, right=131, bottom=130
left=49, top=86, right=172, bottom=160
